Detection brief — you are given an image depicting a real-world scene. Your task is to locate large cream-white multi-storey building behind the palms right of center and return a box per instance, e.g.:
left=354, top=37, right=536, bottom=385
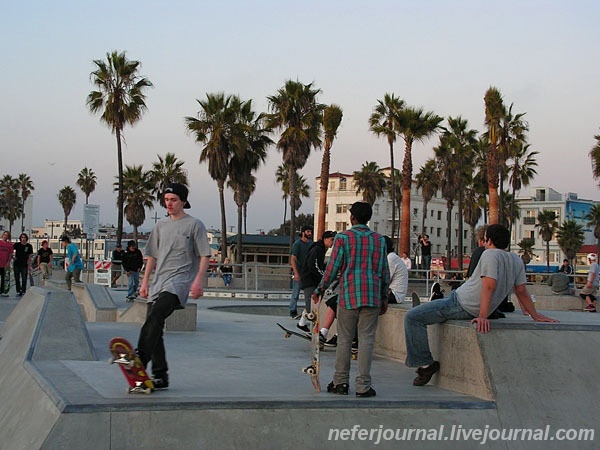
left=314, top=169, right=471, bottom=258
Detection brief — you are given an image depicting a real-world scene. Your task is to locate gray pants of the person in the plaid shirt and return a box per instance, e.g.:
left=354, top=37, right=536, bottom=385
left=333, top=305, right=379, bottom=393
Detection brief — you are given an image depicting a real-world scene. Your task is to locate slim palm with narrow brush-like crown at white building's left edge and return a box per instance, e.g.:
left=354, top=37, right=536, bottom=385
left=317, top=104, right=343, bottom=239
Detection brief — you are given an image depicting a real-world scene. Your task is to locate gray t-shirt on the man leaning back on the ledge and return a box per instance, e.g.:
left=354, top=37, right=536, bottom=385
left=456, top=248, right=527, bottom=317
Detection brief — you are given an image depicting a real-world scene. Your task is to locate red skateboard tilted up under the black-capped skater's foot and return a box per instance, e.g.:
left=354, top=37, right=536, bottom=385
left=108, top=337, right=154, bottom=394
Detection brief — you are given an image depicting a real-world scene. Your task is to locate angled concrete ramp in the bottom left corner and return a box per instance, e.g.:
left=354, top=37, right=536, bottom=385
left=0, top=287, right=95, bottom=449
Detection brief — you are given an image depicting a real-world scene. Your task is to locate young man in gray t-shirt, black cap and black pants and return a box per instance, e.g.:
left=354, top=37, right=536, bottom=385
left=137, top=183, right=210, bottom=389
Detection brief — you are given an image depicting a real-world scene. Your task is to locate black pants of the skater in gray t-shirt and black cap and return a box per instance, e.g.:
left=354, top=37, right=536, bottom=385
left=138, top=292, right=182, bottom=378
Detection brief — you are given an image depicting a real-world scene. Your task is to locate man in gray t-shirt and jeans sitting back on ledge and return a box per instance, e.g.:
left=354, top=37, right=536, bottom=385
left=404, top=224, right=558, bottom=386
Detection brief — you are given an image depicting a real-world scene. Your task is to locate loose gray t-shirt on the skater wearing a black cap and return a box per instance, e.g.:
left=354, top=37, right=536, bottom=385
left=144, top=215, right=210, bottom=306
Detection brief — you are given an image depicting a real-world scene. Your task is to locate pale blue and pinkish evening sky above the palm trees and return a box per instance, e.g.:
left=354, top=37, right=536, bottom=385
left=0, top=0, right=600, bottom=233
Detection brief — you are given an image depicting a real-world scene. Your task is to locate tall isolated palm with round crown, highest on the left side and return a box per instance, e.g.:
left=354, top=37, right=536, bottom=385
left=87, top=51, right=152, bottom=244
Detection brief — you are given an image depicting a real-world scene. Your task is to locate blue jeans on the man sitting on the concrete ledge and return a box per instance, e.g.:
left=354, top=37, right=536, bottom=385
left=404, top=291, right=473, bottom=367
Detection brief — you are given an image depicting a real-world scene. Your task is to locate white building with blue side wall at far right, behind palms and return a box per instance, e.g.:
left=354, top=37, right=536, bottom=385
left=511, top=187, right=599, bottom=267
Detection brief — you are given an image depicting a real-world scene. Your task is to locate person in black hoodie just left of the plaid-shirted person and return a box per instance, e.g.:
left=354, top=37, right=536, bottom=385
left=296, top=231, right=335, bottom=332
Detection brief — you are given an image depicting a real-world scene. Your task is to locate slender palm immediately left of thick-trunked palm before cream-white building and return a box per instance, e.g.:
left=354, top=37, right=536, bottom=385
left=369, top=93, right=405, bottom=239
